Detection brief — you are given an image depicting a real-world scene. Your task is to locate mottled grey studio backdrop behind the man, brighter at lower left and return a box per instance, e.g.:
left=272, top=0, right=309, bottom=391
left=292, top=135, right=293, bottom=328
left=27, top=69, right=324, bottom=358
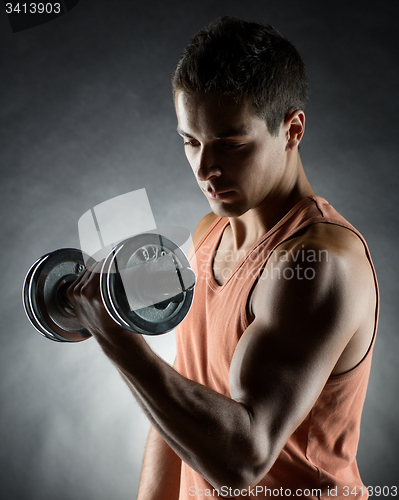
left=0, top=0, right=399, bottom=500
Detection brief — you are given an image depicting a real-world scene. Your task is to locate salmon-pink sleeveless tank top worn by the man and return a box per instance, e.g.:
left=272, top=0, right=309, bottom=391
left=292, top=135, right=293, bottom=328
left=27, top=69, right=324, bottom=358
left=176, top=196, right=379, bottom=500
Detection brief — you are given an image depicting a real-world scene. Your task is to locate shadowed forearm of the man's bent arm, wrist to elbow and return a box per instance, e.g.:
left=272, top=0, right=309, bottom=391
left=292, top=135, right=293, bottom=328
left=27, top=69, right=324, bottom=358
left=98, top=332, right=260, bottom=487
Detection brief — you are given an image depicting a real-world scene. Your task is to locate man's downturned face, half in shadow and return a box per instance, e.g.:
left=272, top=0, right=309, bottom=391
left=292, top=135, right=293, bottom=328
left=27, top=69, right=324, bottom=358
left=175, top=91, right=287, bottom=217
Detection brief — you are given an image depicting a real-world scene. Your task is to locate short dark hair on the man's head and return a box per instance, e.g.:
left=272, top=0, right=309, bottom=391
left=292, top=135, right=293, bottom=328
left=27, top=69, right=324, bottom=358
left=172, top=16, right=308, bottom=135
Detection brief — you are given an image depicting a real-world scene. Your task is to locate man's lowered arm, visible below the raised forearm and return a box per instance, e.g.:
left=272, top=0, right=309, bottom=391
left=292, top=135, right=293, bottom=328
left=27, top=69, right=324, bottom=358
left=137, top=427, right=181, bottom=500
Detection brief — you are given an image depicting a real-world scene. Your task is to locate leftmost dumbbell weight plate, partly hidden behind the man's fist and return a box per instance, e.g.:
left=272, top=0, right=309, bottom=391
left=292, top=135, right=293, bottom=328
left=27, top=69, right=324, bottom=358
left=22, top=248, right=91, bottom=342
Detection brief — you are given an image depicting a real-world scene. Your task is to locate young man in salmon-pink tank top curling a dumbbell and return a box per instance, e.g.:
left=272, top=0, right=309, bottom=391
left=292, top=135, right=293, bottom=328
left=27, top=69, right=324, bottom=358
left=69, top=18, right=378, bottom=500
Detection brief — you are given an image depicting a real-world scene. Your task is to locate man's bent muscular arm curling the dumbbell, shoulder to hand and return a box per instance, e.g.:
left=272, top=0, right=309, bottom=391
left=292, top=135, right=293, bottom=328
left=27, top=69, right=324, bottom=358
left=69, top=225, right=375, bottom=489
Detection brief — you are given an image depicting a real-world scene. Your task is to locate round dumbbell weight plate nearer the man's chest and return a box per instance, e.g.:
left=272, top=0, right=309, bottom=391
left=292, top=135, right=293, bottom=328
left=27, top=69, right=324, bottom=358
left=100, top=233, right=195, bottom=335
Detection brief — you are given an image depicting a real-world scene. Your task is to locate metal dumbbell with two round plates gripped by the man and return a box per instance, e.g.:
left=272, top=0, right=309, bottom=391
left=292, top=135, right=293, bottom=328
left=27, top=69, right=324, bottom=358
left=22, top=233, right=195, bottom=342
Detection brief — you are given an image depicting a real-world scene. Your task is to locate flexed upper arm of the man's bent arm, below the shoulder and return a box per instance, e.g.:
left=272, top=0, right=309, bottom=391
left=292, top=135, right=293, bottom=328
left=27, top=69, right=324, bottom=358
left=229, top=248, right=368, bottom=465
